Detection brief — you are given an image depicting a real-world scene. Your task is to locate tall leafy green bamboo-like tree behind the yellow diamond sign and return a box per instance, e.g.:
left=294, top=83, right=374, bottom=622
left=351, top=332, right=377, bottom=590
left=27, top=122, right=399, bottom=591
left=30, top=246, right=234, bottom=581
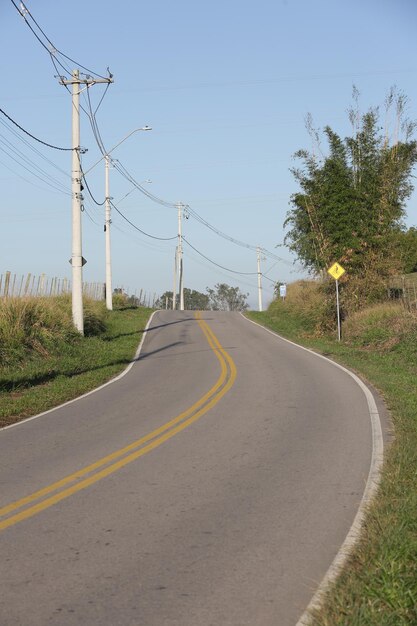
left=284, top=89, right=417, bottom=278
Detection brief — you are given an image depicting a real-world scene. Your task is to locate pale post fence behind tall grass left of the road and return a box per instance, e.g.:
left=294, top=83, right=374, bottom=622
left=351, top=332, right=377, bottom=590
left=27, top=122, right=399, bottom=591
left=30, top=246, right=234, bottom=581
left=0, top=272, right=104, bottom=300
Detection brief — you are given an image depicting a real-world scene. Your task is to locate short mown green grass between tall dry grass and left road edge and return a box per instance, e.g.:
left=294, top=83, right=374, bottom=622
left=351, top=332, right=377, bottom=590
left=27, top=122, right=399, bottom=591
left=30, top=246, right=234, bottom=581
left=0, top=305, right=151, bottom=426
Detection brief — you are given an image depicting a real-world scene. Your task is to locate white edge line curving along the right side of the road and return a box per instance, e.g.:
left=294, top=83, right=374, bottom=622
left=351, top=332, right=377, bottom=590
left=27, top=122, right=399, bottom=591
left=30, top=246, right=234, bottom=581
left=241, top=313, right=384, bottom=626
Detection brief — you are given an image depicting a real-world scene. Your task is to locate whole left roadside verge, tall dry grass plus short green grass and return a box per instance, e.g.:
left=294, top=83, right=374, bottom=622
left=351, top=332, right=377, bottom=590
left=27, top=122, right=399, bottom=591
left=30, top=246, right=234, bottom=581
left=0, top=296, right=151, bottom=426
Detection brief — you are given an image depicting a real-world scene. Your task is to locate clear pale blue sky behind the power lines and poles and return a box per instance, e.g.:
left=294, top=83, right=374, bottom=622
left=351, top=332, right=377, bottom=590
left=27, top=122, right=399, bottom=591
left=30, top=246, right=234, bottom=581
left=0, top=0, right=417, bottom=307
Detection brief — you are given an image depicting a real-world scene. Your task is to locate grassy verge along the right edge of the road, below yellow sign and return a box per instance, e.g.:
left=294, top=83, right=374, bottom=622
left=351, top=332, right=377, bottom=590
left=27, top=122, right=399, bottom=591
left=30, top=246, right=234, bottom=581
left=248, top=302, right=417, bottom=626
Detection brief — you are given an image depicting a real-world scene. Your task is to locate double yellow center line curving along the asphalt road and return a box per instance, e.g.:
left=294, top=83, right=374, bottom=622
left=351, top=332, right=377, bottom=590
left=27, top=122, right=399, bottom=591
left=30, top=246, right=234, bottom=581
left=0, top=313, right=236, bottom=530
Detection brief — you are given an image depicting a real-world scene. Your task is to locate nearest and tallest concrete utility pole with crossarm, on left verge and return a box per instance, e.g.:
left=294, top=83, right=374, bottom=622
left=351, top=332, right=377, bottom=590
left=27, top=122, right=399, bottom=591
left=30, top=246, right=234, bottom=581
left=59, top=70, right=113, bottom=335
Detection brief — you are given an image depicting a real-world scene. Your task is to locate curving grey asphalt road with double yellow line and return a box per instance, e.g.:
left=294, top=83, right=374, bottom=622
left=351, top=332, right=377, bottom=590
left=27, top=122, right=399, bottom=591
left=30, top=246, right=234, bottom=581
left=0, top=311, right=380, bottom=626
